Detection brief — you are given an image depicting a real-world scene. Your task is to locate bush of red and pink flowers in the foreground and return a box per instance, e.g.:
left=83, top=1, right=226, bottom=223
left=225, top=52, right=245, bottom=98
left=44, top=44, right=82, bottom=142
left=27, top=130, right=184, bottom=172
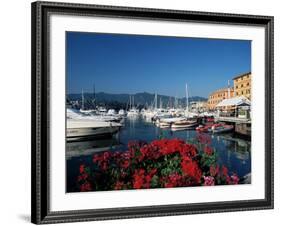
left=77, top=135, right=239, bottom=191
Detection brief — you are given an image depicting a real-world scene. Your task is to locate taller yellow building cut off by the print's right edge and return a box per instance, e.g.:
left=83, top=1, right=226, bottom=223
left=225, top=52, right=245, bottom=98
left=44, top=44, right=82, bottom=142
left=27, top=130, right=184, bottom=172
left=233, top=72, right=251, bottom=100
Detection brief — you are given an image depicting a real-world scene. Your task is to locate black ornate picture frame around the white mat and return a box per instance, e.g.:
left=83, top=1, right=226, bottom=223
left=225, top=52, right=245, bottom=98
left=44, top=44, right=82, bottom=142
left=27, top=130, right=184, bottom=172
left=31, top=2, right=274, bottom=224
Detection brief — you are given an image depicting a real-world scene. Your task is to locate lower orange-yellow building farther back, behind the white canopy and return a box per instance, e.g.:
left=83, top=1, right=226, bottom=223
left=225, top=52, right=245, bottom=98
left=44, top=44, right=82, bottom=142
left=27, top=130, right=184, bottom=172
left=208, top=87, right=234, bottom=110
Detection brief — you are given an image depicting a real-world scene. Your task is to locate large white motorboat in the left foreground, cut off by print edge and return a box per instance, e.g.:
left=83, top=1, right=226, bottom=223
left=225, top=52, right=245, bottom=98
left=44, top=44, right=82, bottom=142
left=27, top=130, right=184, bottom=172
left=66, top=119, right=122, bottom=140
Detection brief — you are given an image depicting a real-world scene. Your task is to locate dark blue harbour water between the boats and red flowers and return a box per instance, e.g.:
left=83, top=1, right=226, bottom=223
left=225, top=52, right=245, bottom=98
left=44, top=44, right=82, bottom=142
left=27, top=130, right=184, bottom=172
left=66, top=117, right=251, bottom=192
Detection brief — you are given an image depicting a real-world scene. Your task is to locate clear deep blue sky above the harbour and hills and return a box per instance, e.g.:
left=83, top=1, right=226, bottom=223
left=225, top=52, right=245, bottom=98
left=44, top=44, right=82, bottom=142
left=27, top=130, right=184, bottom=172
left=66, top=32, right=251, bottom=97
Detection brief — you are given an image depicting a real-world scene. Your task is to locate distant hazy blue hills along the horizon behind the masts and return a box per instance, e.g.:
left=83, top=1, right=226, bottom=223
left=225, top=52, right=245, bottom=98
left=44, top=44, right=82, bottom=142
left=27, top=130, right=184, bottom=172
left=67, top=92, right=207, bottom=107
